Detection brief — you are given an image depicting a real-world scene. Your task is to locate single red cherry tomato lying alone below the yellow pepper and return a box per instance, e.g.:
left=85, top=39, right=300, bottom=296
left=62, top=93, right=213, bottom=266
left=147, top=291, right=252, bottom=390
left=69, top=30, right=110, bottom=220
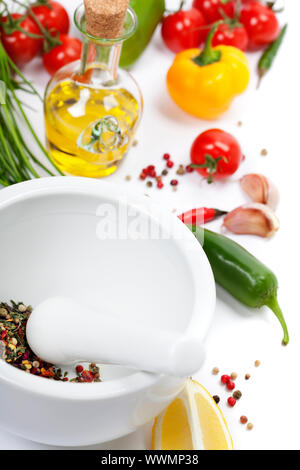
left=191, top=129, right=244, bottom=183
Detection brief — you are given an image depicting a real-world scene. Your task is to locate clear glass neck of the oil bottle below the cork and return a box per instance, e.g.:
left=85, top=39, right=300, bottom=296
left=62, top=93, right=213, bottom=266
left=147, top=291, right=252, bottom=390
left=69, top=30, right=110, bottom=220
left=81, top=39, right=123, bottom=83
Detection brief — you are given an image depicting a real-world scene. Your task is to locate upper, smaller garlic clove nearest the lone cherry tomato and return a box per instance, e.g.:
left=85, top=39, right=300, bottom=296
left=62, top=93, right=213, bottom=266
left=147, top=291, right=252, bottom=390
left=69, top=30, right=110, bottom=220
left=240, top=173, right=279, bottom=210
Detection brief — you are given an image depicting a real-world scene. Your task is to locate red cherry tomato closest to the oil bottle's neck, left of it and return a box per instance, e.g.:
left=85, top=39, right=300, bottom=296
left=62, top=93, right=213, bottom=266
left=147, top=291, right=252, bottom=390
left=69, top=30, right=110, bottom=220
left=43, top=34, right=82, bottom=75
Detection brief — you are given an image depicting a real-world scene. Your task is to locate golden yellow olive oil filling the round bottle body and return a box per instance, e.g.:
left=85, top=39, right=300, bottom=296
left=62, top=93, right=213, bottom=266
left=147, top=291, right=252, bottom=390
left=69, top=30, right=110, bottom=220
left=45, top=77, right=140, bottom=178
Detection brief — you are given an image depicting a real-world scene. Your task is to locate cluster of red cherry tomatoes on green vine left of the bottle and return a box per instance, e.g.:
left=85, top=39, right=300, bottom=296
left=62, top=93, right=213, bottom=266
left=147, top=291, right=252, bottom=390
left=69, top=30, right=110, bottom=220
left=0, top=0, right=82, bottom=75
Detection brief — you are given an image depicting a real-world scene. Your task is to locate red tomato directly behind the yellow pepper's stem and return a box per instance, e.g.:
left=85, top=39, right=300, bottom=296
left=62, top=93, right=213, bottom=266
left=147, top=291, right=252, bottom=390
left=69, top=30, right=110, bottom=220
left=212, top=23, right=249, bottom=51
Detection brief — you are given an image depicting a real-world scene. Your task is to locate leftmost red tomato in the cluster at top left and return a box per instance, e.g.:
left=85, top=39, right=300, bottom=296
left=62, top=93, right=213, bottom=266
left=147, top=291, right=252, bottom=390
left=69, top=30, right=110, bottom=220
left=0, top=13, right=43, bottom=66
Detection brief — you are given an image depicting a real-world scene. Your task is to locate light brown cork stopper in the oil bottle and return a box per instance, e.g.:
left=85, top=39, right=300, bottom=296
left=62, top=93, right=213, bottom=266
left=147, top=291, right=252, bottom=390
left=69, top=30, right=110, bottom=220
left=84, top=0, right=129, bottom=39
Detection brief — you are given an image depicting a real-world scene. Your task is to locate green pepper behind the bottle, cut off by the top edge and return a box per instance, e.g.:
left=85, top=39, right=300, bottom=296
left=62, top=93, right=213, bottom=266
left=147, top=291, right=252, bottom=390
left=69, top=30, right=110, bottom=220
left=120, top=0, right=165, bottom=68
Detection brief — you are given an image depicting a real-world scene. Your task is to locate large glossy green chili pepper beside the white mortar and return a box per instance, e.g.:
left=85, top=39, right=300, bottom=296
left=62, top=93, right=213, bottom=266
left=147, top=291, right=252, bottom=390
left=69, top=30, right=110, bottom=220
left=188, top=225, right=289, bottom=345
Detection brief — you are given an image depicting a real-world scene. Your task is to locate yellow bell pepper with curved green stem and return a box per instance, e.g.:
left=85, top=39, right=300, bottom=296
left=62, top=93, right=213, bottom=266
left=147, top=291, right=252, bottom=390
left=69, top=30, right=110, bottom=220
left=167, top=27, right=250, bottom=119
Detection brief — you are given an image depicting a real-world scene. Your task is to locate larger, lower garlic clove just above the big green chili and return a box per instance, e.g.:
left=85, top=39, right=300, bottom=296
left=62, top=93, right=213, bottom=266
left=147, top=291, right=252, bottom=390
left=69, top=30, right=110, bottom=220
left=223, top=203, right=280, bottom=238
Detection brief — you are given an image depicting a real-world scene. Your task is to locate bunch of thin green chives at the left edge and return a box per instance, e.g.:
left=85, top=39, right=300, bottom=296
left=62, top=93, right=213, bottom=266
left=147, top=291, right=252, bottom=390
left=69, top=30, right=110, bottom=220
left=0, top=41, right=63, bottom=186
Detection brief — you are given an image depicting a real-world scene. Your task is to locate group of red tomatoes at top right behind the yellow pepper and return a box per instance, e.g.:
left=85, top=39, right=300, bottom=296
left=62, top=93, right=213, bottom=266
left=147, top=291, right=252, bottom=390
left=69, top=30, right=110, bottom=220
left=162, top=0, right=280, bottom=53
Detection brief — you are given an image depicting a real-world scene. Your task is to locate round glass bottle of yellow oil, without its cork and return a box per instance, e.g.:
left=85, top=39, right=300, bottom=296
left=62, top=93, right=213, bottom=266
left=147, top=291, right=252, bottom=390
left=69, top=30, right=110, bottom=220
left=44, top=5, right=143, bottom=178
